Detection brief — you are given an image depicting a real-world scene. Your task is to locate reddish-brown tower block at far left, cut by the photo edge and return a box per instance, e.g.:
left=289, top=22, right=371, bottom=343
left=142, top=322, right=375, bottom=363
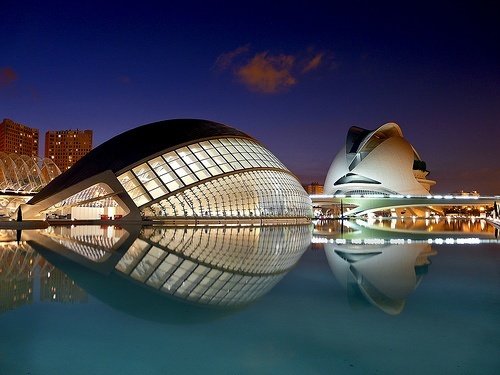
left=0, top=119, right=39, bottom=158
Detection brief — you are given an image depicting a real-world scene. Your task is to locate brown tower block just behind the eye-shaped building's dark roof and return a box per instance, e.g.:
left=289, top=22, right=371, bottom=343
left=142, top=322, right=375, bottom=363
left=44, top=130, right=92, bottom=172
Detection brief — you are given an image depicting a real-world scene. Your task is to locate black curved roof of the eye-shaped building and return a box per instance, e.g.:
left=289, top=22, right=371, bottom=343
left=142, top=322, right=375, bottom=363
left=28, top=119, right=257, bottom=204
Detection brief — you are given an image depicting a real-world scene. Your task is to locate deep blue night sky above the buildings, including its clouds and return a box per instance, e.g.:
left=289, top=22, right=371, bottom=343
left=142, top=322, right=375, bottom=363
left=0, top=0, right=500, bottom=195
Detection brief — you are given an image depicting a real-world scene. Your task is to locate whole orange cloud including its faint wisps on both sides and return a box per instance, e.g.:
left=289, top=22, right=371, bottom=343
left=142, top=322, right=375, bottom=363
left=214, top=45, right=334, bottom=94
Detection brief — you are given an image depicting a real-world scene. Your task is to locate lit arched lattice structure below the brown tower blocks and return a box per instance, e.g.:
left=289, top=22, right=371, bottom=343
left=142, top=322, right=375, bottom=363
left=0, top=151, right=61, bottom=193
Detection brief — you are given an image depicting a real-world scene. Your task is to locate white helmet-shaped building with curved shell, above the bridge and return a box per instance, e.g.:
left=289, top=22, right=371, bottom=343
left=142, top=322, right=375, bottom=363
left=324, top=122, right=435, bottom=195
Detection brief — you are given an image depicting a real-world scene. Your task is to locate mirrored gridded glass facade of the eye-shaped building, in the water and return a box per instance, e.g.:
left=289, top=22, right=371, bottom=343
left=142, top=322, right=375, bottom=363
left=116, top=225, right=312, bottom=307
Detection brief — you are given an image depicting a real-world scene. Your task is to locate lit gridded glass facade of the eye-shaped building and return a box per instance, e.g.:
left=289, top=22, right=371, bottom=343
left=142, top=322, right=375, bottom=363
left=118, top=137, right=312, bottom=218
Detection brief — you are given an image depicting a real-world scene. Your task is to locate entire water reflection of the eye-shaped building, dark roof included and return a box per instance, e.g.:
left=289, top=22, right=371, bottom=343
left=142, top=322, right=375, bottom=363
left=23, top=225, right=312, bottom=323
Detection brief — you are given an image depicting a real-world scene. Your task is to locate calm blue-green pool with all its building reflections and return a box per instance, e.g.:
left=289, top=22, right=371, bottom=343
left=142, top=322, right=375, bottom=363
left=0, top=220, right=500, bottom=374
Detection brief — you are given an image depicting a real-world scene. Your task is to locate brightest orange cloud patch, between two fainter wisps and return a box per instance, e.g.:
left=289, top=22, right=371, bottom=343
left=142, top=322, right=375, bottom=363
left=236, top=52, right=297, bottom=94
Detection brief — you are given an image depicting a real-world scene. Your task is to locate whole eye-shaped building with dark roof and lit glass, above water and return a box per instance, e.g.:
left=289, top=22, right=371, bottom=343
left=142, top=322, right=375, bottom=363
left=22, top=120, right=312, bottom=220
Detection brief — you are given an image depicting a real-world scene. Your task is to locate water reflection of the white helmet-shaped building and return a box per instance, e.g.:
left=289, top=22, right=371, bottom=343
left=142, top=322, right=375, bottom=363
left=324, top=243, right=435, bottom=314
